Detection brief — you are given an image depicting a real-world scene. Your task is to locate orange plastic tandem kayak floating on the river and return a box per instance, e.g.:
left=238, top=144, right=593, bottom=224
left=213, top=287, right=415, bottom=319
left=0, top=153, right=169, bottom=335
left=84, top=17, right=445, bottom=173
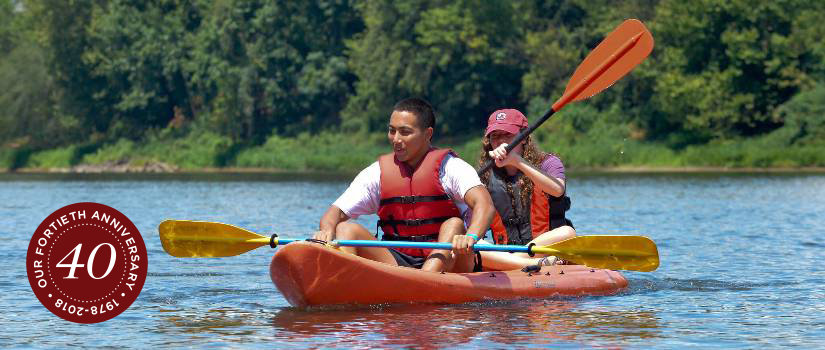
left=269, top=242, right=627, bottom=307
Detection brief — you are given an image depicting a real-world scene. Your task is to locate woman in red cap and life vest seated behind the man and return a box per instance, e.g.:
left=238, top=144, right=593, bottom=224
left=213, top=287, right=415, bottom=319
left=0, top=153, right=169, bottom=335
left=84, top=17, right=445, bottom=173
left=479, top=109, right=576, bottom=270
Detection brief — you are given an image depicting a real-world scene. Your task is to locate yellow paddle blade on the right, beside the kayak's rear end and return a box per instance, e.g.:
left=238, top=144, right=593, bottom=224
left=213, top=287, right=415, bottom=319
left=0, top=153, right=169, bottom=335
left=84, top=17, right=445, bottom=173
left=532, top=236, right=659, bottom=272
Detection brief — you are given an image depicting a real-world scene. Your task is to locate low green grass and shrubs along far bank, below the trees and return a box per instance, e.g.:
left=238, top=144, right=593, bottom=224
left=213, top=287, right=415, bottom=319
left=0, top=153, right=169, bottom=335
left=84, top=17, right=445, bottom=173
left=6, top=103, right=825, bottom=172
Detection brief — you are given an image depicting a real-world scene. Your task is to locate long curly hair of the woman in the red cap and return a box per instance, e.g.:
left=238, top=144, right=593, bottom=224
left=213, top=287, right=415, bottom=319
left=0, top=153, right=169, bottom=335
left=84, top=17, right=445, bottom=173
left=478, top=131, right=552, bottom=210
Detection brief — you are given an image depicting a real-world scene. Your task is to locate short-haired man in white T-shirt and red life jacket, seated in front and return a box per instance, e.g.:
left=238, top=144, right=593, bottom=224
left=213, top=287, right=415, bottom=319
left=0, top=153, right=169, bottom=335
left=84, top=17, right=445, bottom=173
left=314, top=98, right=495, bottom=272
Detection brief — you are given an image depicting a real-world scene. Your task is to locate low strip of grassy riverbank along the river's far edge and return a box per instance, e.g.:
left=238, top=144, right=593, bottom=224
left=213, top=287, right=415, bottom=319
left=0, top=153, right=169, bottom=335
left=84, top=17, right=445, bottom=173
left=0, top=129, right=825, bottom=174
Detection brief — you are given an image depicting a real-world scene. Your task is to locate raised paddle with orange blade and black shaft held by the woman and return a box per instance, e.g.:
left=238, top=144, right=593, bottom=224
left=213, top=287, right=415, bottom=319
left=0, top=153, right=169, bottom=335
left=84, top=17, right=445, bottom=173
left=478, top=19, right=653, bottom=175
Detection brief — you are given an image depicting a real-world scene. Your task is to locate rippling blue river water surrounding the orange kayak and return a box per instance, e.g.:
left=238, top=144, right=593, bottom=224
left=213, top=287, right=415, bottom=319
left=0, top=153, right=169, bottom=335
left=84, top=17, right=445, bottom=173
left=0, top=174, right=825, bottom=348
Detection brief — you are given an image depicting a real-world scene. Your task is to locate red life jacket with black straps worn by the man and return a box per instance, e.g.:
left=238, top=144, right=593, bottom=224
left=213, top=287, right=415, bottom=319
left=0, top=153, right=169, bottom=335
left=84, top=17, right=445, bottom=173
left=378, top=148, right=461, bottom=257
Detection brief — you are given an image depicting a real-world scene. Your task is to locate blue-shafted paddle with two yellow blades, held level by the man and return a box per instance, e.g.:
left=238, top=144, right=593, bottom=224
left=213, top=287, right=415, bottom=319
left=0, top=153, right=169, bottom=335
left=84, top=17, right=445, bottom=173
left=158, top=220, right=659, bottom=272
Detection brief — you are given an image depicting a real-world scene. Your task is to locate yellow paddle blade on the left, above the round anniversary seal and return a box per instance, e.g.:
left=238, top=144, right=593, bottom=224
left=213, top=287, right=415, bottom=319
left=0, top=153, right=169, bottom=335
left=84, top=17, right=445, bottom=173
left=158, top=220, right=269, bottom=258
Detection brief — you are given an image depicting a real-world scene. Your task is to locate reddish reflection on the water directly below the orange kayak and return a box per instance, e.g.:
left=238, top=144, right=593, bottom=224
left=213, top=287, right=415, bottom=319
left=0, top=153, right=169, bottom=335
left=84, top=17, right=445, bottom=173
left=272, top=300, right=658, bottom=347
